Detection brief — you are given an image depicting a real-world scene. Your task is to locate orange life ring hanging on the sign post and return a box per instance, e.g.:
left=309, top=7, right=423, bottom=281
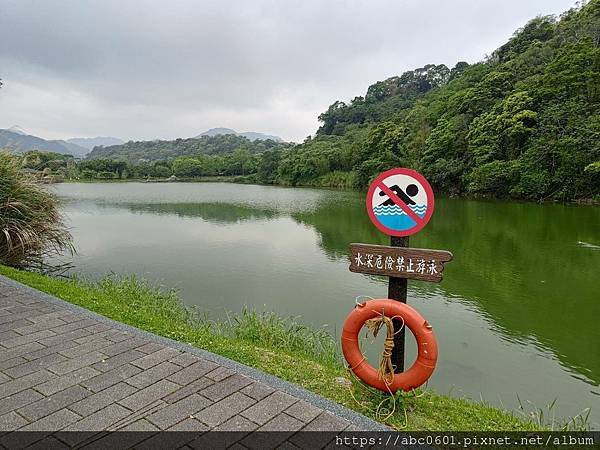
left=342, top=299, right=438, bottom=392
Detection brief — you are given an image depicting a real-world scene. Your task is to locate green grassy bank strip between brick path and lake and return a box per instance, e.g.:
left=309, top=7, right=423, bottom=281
left=0, top=265, right=574, bottom=431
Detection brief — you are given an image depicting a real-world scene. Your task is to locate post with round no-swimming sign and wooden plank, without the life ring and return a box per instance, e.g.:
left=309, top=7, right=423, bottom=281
left=350, top=169, right=452, bottom=373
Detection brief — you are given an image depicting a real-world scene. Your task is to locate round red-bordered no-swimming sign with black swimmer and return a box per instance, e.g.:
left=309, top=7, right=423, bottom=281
left=367, top=168, right=434, bottom=236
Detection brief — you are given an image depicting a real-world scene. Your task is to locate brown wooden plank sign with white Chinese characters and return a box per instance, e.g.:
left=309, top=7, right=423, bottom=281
left=350, top=244, right=453, bottom=282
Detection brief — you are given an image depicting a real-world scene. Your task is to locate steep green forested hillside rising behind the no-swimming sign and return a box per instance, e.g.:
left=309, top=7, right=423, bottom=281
left=277, top=0, right=600, bottom=200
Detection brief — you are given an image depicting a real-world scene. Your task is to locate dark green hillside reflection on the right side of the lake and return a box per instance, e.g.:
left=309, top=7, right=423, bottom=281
left=292, top=199, right=600, bottom=386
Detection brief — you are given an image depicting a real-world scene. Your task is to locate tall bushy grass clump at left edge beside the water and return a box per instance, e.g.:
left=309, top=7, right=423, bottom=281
left=0, top=151, right=73, bottom=268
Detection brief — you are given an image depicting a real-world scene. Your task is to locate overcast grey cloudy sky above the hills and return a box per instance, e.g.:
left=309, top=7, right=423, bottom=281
left=0, top=0, right=574, bottom=141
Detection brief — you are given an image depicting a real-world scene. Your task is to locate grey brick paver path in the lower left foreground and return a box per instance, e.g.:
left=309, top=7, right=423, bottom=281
left=0, top=277, right=384, bottom=444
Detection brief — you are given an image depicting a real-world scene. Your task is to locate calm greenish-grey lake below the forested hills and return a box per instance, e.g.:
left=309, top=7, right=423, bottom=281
left=54, top=183, right=600, bottom=429
